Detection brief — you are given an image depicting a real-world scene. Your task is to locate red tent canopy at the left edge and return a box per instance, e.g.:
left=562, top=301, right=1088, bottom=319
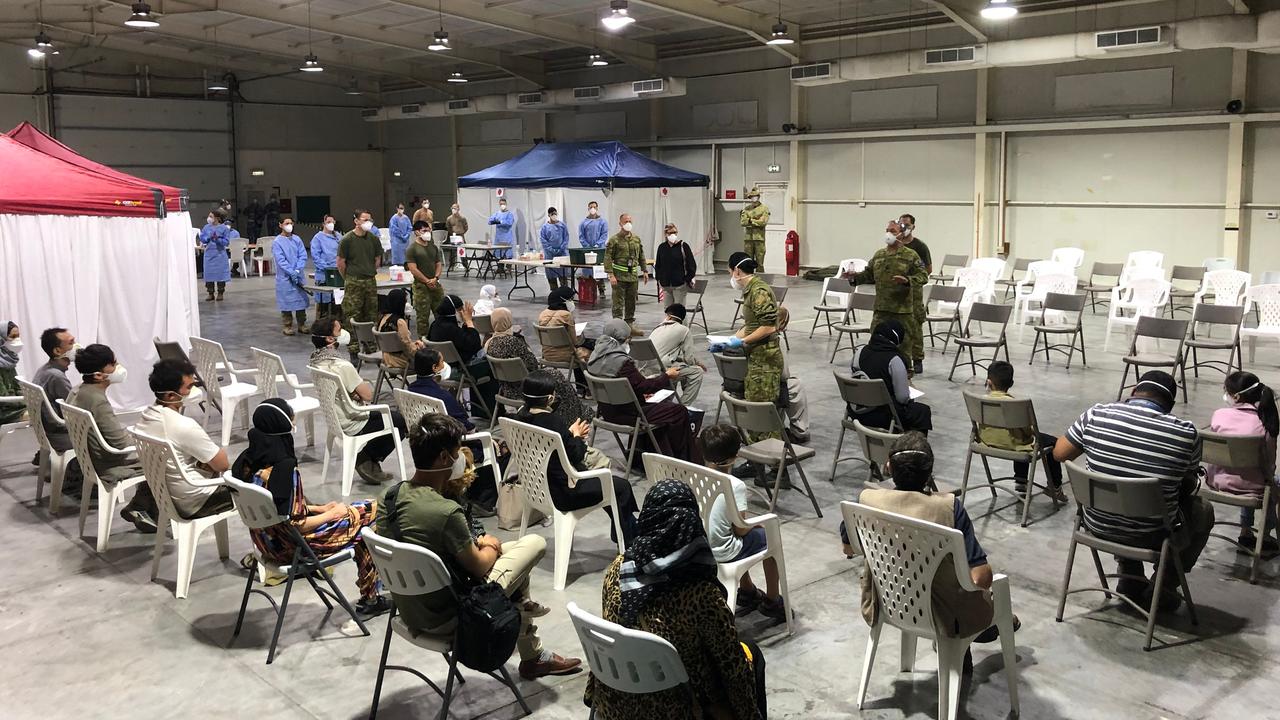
left=0, top=123, right=187, bottom=218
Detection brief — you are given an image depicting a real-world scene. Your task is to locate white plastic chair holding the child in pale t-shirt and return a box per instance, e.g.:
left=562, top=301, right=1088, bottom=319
left=644, top=452, right=795, bottom=634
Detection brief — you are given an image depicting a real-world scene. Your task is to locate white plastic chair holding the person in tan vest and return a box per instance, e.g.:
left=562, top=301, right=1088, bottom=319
left=840, top=501, right=1019, bottom=720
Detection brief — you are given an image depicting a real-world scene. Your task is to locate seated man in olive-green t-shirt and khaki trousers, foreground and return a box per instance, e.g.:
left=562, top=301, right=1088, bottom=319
left=375, top=413, right=582, bottom=680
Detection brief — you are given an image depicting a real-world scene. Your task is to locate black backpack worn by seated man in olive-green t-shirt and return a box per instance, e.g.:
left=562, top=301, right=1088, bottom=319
left=385, top=483, right=520, bottom=673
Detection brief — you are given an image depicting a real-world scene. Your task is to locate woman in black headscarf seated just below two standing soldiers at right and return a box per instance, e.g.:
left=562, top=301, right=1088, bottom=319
left=849, top=318, right=933, bottom=434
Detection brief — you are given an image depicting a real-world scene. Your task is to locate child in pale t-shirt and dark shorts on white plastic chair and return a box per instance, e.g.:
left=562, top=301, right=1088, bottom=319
left=698, top=424, right=787, bottom=621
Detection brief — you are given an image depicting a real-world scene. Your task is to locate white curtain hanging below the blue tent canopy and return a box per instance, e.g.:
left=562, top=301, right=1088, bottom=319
left=458, top=187, right=714, bottom=273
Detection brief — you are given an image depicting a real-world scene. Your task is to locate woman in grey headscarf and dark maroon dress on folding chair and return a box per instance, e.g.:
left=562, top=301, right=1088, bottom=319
left=586, top=318, right=703, bottom=464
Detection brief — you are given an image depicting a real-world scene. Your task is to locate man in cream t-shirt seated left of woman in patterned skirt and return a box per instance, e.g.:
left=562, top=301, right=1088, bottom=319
left=133, top=360, right=233, bottom=520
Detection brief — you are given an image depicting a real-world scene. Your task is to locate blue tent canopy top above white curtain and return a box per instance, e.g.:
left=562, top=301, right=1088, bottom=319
left=458, top=141, right=710, bottom=188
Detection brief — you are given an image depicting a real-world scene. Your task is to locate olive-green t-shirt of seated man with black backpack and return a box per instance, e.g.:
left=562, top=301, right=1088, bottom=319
left=375, top=483, right=474, bottom=632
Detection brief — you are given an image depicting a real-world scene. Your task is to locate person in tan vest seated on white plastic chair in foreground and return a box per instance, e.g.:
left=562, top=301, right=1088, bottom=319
left=840, top=430, right=1019, bottom=673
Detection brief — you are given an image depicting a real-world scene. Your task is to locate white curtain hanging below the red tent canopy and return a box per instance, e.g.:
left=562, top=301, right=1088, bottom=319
left=0, top=213, right=200, bottom=410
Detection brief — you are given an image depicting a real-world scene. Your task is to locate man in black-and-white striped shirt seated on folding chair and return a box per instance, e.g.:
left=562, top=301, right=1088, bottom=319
left=1053, top=370, right=1213, bottom=612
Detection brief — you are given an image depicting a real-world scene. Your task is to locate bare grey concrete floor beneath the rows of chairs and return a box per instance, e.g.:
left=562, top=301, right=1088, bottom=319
left=0, top=265, right=1280, bottom=720
